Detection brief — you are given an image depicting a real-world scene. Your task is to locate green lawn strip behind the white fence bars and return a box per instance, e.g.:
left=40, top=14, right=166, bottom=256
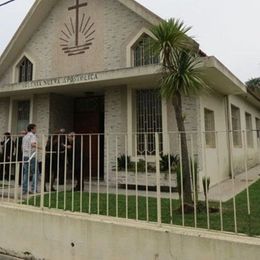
left=24, top=180, right=260, bottom=236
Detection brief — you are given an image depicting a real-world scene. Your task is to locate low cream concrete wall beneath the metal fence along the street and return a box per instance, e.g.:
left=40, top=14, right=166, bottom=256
left=0, top=204, right=260, bottom=260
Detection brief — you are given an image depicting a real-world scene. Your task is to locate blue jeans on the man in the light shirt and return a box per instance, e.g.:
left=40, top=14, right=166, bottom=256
left=23, top=157, right=39, bottom=193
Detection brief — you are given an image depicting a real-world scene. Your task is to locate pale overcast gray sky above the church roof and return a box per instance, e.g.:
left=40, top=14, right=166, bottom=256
left=0, top=0, right=260, bottom=81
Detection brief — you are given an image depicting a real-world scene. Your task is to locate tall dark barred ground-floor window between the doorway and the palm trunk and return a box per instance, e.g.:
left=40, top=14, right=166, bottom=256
left=136, top=90, right=162, bottom=155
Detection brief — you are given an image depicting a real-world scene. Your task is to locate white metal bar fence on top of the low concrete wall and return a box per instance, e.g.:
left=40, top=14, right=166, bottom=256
left=0, top=131, right=260, bottom=236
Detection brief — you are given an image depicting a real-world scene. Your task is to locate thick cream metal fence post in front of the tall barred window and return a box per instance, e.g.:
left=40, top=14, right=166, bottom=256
left=155, top=133, right=162, bottom=224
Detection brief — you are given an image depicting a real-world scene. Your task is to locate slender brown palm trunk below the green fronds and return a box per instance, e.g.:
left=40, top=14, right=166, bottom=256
left=172, top=93, right=192, bottom=204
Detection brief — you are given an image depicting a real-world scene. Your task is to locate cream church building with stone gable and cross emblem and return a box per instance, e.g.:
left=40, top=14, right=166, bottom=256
left=0, top=0, right=260, bottom=187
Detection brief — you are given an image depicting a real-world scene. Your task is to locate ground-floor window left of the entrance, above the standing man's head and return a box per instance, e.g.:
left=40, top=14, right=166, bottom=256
left=16, top=100, right=30, bottom=133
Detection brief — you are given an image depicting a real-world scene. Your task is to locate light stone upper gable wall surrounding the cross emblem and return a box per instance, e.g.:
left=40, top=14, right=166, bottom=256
left=0, top=0, right=151, bottom=86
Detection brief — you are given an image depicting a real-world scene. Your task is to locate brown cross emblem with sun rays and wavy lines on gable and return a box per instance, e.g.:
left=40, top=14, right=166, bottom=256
left=60, top=0, right=95, bottom=56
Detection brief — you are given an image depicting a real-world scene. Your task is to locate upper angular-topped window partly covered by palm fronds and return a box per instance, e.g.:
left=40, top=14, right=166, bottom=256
left=133, top=34, right=160, bottom=67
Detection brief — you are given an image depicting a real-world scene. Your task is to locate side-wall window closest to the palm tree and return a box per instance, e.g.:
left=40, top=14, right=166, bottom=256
left=204, top=108, right=216, bottom=148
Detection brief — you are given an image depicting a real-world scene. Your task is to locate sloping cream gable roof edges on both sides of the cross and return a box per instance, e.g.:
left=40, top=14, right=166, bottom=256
left=0, top=0, right=162, bottom=77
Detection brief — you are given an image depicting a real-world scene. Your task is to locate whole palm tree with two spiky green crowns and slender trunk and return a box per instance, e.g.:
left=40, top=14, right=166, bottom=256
left=151, top=19, right=205, bottom=205
